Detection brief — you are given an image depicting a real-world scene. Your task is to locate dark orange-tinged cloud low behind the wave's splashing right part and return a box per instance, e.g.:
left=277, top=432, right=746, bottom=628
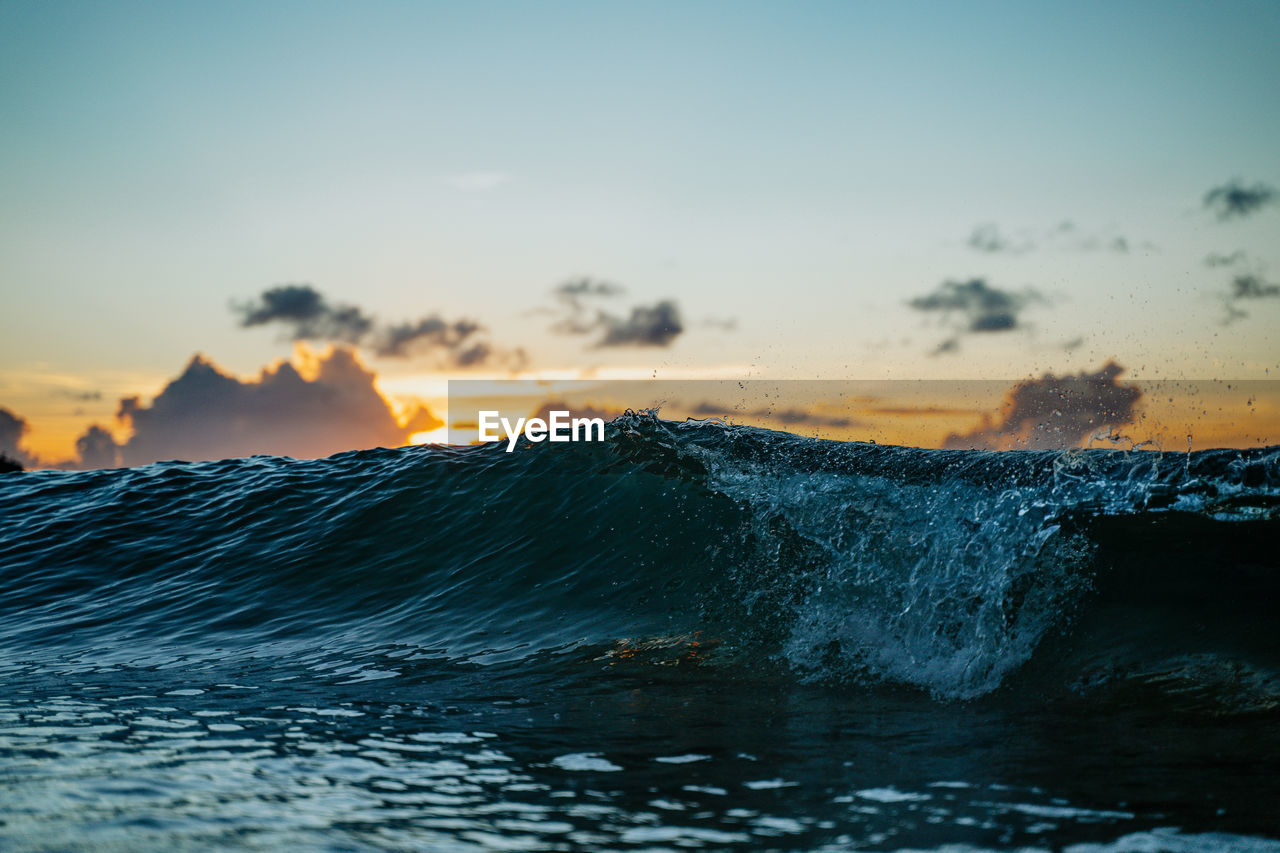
left=942, top=361, right=1142, bottom=450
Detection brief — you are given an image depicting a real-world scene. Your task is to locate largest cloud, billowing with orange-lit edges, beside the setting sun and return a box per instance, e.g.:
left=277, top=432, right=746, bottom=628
left=115, top=347, right=407, bottom=465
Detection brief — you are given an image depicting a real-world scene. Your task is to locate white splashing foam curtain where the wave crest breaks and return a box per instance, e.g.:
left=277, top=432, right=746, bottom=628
left=710, top=460, right=1085, bottom=698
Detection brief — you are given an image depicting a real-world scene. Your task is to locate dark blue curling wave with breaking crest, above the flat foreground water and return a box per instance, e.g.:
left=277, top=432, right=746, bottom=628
left=0, top=415, right=1280, bottom=699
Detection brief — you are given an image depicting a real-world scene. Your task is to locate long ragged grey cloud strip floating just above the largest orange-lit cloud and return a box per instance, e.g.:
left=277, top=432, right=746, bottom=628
left=233, top=284, right=525, bottom=369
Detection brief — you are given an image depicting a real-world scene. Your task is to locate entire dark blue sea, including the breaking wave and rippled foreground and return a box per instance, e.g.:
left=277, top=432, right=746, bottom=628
left=0, top=416, right=1280, bottom=850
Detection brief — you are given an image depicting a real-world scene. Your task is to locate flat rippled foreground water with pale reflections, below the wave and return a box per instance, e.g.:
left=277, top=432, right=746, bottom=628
left=0, top=650, right=1280, bottom=850
